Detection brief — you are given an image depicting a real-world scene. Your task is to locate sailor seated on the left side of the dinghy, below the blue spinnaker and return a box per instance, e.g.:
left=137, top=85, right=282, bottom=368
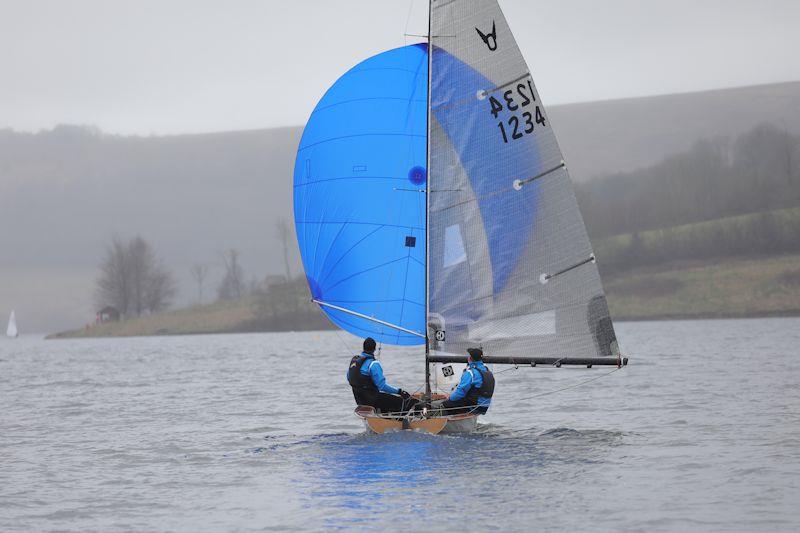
left=347, top=337, right=417, bottom=413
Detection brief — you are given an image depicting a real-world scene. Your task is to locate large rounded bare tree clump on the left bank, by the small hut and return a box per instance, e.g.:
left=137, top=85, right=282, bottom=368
left=96, top=236, right=176, bottom=316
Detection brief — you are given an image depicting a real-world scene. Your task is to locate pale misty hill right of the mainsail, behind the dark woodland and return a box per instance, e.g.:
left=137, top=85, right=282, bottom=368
left=549, top=82, right=800, bottom=181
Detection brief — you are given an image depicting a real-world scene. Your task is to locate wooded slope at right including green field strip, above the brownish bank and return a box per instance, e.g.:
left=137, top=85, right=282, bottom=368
left=576, top=124, right=800, bottom=274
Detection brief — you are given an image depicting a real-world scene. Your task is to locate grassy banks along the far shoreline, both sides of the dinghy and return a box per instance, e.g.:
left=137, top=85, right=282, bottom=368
left=49, top=254, right=800, bottom=338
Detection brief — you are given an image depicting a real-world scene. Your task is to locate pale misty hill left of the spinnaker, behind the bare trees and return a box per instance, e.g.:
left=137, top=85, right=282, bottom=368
left=0, top=126, right=299, bottom=332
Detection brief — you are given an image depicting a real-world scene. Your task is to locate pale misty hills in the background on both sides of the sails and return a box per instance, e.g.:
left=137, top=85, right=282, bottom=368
left=0, top=82, right=800, bottom=332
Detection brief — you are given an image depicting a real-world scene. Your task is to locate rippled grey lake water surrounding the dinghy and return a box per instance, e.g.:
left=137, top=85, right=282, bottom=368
left=0, top=318, right=800, bottom=532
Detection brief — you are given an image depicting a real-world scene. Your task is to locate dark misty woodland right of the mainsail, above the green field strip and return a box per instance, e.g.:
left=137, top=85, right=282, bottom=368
left=575, top=124, right=800, bottom=238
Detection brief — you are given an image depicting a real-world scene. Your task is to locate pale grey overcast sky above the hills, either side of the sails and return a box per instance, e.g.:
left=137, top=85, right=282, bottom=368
left=0, top=0, right=800, bottom=135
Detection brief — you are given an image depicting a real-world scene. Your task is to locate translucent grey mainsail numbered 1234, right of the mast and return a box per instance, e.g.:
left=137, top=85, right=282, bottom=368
left=428, top=0, right=619, bottom=357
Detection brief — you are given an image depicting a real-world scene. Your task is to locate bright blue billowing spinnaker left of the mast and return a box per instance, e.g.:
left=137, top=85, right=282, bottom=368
left=294, top=45, right=428, bottom=345
